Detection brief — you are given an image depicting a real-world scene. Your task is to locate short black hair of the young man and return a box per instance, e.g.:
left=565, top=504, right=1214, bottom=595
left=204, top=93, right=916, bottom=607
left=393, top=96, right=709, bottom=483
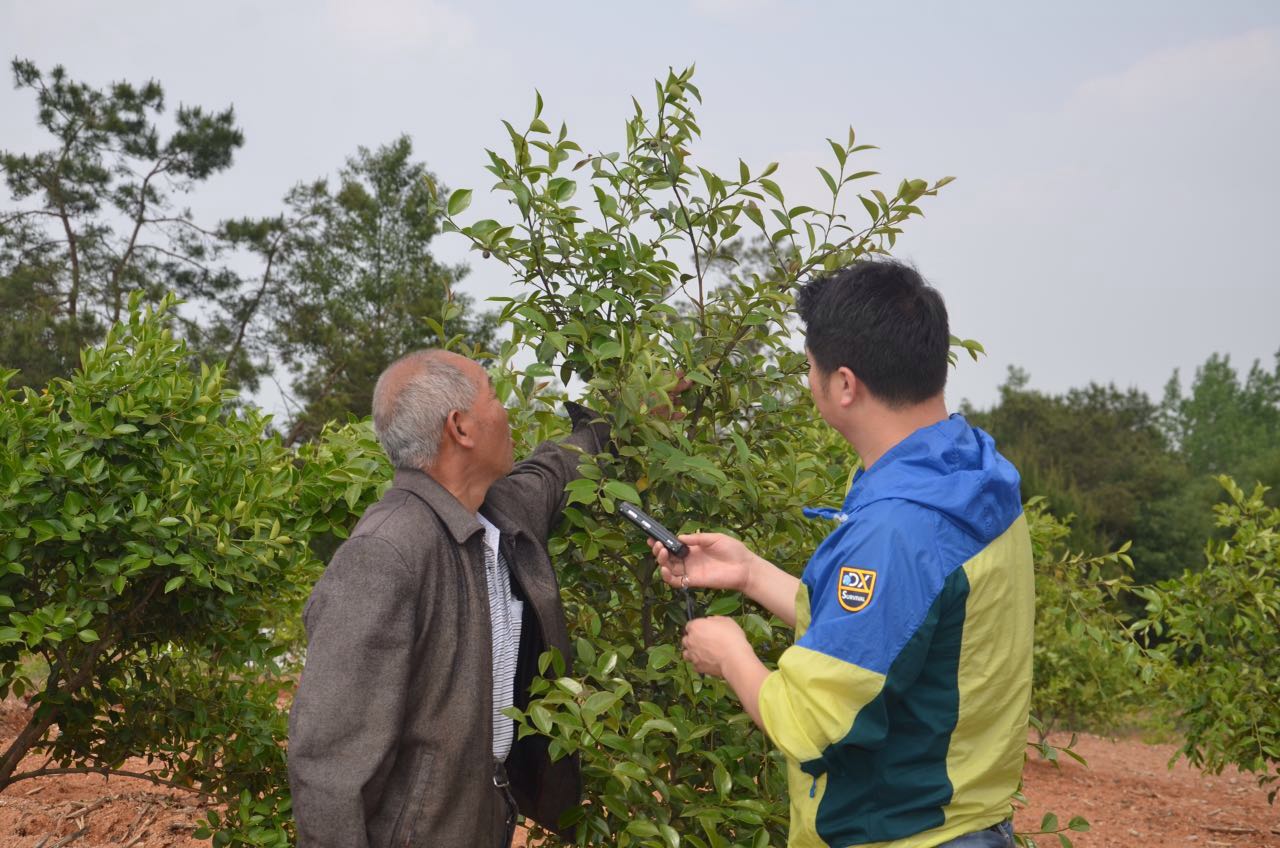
left=796, top=260, right=951, bottom=407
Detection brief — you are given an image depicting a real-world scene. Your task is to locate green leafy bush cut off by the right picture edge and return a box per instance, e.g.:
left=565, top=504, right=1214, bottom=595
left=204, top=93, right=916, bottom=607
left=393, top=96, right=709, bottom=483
left=1134, top=477, right=1280, bottom=801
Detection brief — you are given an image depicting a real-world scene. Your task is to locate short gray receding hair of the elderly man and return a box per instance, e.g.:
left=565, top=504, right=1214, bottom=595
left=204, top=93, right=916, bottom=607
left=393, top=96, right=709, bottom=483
left=374, top=350, right=476, bottom=469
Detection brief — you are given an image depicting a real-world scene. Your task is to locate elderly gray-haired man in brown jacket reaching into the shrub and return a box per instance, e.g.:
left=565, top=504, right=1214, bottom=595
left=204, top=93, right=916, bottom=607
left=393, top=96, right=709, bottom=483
left=289, top=351, right=608, bottom=848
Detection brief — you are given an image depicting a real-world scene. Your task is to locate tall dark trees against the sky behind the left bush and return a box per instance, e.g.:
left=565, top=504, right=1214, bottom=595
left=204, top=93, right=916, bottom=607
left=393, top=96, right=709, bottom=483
left=0, top=59, right=494, bottom=443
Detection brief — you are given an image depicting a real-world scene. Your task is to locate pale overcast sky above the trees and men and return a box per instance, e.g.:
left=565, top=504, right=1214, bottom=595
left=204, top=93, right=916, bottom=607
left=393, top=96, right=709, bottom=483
left=0, top=0, right=1280, bottom=406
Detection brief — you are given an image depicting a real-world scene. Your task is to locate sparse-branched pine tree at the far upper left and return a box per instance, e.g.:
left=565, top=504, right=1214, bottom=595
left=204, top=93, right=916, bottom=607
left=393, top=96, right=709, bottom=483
left=0, top=59, right=243, bottom=386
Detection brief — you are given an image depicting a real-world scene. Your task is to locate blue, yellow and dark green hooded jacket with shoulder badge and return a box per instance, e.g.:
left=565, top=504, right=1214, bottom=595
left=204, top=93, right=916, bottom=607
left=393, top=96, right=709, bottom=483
left=760, top=415, right=1034, bottom=848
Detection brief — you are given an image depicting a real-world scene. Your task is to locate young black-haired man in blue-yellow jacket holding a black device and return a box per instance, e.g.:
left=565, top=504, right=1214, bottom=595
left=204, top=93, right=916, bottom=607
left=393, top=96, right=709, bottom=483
left=654, top=261, right=1034, bottom=848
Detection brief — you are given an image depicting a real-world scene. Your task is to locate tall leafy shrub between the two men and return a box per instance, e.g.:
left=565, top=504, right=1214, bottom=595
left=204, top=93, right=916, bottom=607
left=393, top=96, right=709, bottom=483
left=440, top=69, right=946, bottom=848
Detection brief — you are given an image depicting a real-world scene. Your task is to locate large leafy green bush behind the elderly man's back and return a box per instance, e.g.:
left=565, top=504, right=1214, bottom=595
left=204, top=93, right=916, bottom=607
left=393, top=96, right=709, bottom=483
left=0, top=297, right=388, bottom=845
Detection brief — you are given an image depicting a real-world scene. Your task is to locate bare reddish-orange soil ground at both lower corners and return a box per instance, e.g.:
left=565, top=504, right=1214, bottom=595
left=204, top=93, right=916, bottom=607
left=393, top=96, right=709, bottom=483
left=0, top=698, right=1280, bottom=848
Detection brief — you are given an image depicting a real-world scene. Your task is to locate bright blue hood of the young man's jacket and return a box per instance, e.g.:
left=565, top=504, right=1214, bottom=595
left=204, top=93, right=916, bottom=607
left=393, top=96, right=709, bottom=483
left=844, top=414, right=1023, bottom=542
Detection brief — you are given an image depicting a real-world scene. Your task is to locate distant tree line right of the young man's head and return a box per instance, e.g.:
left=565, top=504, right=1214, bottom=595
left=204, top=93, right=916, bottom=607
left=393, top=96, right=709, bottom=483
left=964, top=351, right=1280, bottom=583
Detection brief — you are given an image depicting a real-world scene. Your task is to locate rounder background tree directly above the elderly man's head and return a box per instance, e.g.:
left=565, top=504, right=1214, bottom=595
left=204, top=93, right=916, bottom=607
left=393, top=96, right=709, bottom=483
left=218, top=136, right=495, bottom=442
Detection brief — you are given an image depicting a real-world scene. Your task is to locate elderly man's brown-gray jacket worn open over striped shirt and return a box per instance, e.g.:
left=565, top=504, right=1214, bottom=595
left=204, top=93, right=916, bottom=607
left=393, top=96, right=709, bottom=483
left=289, top=405, right=608, bottom=848
